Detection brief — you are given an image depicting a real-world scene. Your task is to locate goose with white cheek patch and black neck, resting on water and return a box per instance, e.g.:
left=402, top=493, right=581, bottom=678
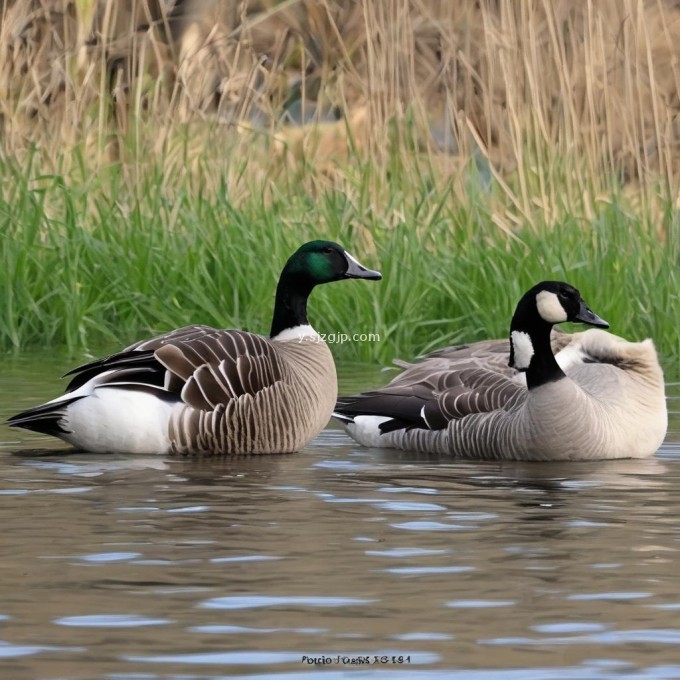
left=333, top=281, right=668, bottom=461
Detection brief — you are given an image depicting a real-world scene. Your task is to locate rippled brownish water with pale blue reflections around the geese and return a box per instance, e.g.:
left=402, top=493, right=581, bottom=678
left=0, top=355, right=680, bottom=680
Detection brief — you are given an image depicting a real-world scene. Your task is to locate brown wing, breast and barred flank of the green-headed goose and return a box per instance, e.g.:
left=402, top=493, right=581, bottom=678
left=53, top=326, right=337, bottom=454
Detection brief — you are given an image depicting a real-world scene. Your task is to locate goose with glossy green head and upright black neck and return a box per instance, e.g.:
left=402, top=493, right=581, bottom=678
left=8, top=241, right=381, bottom=455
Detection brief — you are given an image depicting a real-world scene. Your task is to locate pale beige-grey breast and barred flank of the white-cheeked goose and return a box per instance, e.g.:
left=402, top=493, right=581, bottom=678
left=383, top=329, right=667, bottom=460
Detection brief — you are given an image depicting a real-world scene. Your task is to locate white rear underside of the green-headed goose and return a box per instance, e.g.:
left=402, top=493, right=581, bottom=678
left=49, top=371, right=182, bottom=454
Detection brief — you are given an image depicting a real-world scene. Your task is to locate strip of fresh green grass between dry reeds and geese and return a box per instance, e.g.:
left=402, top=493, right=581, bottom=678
left=0, top=145, right=680, bottom=363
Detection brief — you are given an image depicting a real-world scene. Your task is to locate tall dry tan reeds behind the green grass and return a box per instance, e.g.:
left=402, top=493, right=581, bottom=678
left=0, top=0, right=680, bottom=226
